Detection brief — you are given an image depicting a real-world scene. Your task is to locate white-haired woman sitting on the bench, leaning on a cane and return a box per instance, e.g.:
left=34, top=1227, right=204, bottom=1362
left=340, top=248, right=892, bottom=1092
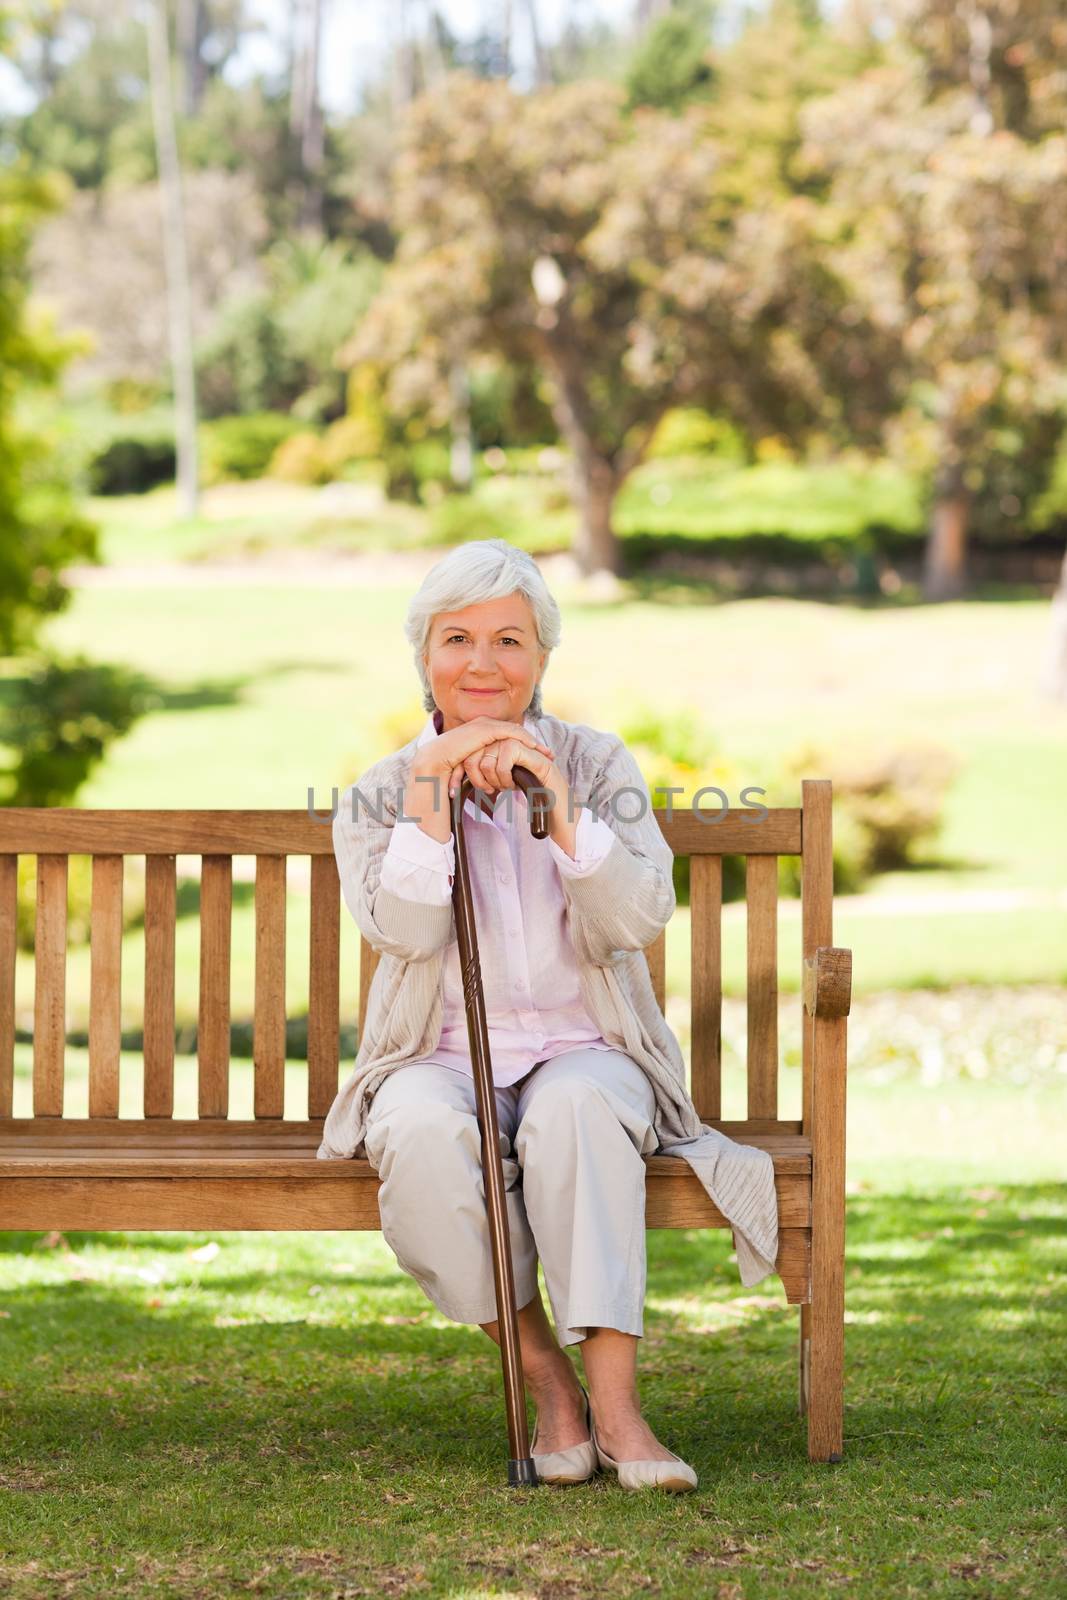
left=318, top=539, right=773, bottom=1490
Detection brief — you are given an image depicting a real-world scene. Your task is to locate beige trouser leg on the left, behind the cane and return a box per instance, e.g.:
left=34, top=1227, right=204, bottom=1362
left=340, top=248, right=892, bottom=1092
left=365, top=1062, right=537, bottom=1323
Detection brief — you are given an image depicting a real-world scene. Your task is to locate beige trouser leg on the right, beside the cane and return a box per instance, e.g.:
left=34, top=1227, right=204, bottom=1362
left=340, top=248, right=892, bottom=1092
left=515, top=1050, right=659, bottom=1346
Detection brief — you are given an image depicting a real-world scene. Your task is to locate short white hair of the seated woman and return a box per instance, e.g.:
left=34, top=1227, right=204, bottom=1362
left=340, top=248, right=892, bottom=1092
left=403, top=539, right=561, bottom=717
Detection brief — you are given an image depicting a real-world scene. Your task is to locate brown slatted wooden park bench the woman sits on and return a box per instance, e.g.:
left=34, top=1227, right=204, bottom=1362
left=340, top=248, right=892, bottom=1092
left=0, top=779, right=851, bottom=1461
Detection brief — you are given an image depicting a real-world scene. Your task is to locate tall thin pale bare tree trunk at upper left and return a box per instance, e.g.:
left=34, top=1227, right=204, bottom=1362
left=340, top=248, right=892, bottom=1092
left=147, top=0, right=200, bottom=517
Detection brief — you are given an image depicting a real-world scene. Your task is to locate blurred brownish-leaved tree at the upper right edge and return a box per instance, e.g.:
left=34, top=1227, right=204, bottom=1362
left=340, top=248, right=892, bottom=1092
left=805, top=0, right=1067, bottom=600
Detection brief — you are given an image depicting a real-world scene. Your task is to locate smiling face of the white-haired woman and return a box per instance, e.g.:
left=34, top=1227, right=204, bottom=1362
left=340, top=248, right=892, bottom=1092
left=422, top=594, right=547, bottom=733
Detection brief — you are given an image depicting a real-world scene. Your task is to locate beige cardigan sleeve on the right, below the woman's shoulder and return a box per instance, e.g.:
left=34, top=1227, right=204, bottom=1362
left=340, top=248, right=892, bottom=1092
left=560, top=741, right=677, bottom=966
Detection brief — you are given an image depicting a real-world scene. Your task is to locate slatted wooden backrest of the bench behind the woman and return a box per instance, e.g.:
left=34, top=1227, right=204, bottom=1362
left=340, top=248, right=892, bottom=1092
left=0, top=779, right=833, bottom=1133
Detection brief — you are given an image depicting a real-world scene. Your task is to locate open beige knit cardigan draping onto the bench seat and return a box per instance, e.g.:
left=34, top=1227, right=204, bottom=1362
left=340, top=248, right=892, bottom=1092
left=317, top=714, right=777, bottom=1286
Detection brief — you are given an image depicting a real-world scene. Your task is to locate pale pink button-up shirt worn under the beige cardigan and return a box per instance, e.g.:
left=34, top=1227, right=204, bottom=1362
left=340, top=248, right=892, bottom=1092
left=381, top=710, right=616, bottom=1086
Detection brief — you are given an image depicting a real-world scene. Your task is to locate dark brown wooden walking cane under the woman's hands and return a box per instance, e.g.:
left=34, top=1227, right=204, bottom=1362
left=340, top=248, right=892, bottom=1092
left=453, top=766, right=550, bottom=1488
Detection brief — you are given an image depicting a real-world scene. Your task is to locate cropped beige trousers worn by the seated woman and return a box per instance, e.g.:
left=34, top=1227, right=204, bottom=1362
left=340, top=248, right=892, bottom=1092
left=365, top=1048, right=659, bottom=1346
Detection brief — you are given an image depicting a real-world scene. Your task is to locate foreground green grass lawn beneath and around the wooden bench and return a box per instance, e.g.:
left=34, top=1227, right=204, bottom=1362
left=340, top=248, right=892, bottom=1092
left=0, top=1049, right=1067, bottom=1600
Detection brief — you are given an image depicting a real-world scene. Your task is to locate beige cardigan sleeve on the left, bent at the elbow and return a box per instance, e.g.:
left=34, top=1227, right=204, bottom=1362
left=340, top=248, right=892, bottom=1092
left=333, top=768, right=453, bottom=962
